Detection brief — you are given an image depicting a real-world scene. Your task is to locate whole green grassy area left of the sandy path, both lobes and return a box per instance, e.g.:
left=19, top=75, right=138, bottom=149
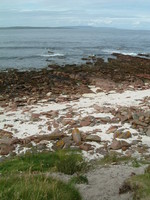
left=0, top=150, right=86, bottom=200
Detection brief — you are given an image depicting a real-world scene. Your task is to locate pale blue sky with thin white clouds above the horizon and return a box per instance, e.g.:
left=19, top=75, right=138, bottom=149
left=0, top=0, right=150, bottom=30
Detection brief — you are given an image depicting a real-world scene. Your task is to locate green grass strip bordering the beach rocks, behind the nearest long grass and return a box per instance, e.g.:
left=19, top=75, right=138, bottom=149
left=0, top=150, right=86, bottom=174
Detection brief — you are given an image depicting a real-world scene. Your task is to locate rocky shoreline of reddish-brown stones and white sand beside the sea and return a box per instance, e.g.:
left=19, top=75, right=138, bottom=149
left=0, top=54, right=150, bottom=160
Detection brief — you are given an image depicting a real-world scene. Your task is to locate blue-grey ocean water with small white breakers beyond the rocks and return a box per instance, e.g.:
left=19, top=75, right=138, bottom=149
left=0, top=27, right=150, bottom=69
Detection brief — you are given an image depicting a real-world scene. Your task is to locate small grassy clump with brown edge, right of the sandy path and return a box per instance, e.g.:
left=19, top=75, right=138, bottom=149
left=121, top=165, right=150, bottom=200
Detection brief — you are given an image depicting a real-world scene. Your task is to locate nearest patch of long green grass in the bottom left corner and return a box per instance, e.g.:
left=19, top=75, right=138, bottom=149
left=0, top=174, right=81, bottom=200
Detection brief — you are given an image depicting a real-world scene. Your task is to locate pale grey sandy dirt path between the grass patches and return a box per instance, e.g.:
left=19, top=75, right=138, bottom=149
left=77, top=165, right=144, bottom=200
